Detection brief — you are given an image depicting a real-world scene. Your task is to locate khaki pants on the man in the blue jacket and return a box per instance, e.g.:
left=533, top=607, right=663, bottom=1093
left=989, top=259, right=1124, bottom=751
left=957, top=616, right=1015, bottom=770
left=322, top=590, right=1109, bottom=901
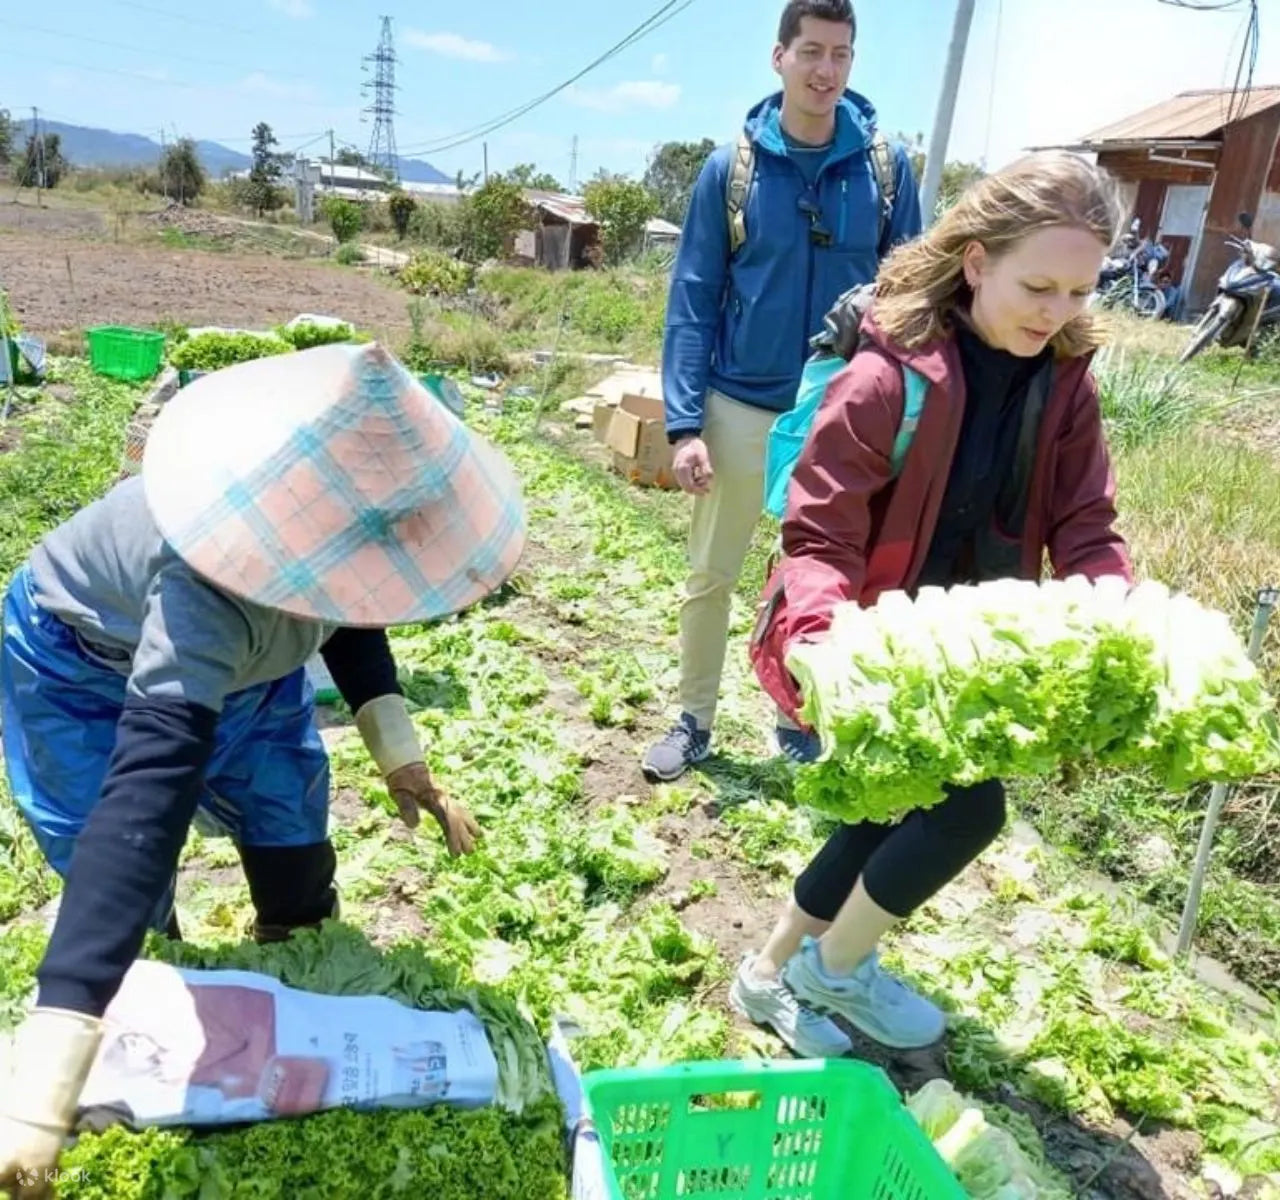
left=680, top=391, right=778, bottom=729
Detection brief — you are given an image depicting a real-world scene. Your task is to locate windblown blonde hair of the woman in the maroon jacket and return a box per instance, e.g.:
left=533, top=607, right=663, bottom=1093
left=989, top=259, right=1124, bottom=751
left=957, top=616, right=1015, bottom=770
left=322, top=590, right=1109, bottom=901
left=873, top=151, right=1124, bottom=358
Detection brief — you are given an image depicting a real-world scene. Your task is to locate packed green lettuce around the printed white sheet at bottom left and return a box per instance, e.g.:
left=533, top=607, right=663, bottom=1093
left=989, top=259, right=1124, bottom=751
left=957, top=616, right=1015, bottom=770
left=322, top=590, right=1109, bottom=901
left=20, top=922, right=567, bottom=1200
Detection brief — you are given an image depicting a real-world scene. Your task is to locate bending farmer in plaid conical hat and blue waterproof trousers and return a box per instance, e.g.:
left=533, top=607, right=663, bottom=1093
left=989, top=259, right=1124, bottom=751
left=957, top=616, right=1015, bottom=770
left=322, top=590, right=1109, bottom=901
left=0, top=344, right=525, bottom=1196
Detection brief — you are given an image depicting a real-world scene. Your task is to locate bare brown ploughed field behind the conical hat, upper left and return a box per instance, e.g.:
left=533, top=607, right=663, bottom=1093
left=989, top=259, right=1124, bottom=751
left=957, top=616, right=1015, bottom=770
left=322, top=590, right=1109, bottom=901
left=0, top=203, right=410, bottom=340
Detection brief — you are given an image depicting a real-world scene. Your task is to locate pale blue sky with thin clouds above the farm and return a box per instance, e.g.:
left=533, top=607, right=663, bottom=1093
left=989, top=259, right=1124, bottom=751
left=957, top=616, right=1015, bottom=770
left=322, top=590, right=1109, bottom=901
left=0, top=0, right=1280, bottom=180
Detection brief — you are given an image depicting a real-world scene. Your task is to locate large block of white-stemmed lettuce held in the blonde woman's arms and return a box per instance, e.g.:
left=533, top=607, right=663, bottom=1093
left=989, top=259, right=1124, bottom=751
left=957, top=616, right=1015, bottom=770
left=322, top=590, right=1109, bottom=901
left=787, top=577, right=1280, bottom=821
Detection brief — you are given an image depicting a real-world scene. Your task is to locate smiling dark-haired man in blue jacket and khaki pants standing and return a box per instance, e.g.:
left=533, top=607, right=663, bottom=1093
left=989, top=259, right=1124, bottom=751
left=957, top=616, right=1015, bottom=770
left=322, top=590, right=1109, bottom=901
left=644, top=0, right=920, bottom=782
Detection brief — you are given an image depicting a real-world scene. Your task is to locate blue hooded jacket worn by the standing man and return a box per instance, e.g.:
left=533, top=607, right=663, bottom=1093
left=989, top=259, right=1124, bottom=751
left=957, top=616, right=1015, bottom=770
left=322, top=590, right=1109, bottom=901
left=662, top=91, right=922, bottom=439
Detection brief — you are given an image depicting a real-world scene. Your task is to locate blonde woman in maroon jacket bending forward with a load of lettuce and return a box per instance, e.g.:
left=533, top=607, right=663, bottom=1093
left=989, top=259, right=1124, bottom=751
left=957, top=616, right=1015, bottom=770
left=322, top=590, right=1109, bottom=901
left=730, top=154, right=1133, bottom=1057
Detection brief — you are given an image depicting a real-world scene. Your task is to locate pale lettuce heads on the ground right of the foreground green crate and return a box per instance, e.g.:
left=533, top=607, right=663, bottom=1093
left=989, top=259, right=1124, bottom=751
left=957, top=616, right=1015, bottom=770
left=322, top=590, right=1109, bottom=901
left=906, top=1080, right=1071, bottom=1200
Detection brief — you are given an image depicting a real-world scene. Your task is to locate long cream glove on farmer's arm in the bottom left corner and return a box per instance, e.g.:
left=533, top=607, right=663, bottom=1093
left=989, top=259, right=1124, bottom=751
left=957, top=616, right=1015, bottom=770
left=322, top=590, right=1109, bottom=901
left=0, top=1008, right=102, bottom=1200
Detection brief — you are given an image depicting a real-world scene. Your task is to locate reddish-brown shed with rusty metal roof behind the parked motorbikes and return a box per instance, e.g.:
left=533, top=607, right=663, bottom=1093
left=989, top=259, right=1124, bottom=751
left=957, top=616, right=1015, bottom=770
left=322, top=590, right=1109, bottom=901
left=1057, top=87, right=1280, bottom=315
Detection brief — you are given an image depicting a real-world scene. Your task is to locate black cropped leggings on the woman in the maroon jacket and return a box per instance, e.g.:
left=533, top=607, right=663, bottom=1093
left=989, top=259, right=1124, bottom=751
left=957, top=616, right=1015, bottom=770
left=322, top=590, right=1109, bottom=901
left=795, top=779, right=1005, bottom=921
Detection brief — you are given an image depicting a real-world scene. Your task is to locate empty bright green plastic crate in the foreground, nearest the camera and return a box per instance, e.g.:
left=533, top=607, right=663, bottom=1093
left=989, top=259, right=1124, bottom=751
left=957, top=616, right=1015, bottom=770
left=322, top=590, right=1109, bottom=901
left=582, top=1058, right=965, bottom=1200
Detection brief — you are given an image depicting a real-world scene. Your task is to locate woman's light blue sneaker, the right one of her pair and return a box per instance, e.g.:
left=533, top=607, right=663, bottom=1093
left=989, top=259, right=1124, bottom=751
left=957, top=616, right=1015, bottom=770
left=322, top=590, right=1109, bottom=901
left=782, top=938, right=947, bottom=1050
